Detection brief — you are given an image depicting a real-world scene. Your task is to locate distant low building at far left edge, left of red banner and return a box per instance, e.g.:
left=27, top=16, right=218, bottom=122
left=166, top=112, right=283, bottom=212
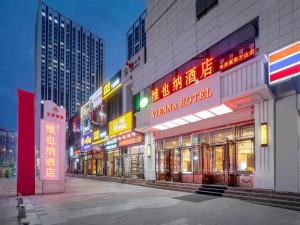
left=0, top=128, right=17, bottom=165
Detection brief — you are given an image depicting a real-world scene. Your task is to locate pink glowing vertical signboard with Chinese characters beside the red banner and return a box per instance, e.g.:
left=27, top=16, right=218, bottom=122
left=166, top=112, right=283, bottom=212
left=40, top=101, right=66, bottom=193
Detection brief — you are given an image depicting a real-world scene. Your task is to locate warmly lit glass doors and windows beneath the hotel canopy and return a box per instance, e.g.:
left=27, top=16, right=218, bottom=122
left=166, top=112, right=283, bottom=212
left=155, top=123, right=255, bottom=186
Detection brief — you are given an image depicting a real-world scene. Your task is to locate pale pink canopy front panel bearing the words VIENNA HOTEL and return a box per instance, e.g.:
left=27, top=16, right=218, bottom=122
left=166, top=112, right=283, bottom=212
left=150, top=72, right=221, bottom=126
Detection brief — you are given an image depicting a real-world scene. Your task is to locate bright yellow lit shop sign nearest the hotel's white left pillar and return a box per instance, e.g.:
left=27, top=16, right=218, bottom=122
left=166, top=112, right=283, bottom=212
left=109, top=112, right=133, bottom=136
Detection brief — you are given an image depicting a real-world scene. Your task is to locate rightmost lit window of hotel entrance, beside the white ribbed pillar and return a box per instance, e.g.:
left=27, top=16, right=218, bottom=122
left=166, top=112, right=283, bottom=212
left=237, top=140, right=254, bottom=173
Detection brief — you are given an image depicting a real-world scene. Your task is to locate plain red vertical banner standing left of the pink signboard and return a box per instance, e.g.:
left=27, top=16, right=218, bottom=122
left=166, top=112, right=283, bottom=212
left=17, top=89, right=35, bottom=195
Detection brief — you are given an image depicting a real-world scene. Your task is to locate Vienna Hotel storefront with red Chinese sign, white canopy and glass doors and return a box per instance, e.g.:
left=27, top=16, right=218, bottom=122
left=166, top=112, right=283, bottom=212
left=135, top=21, right=274, bottom=189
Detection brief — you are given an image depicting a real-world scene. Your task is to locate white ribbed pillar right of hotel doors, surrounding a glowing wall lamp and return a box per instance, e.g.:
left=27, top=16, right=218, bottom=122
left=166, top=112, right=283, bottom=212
left=253, top=100, right=274, bottom=189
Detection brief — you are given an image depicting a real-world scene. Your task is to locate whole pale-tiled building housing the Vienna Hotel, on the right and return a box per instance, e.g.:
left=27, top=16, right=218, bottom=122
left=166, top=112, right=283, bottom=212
left=126, top=0, right=300, bottom=192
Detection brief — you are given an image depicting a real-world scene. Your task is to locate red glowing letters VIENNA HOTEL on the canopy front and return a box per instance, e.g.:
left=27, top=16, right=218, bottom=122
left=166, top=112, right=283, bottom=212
left=151, top=88, right=213, bottom=118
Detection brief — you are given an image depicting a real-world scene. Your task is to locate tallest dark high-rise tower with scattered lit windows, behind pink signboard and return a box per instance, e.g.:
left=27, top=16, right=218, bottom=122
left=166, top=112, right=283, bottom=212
left=35, top=2, right=104, bottom=118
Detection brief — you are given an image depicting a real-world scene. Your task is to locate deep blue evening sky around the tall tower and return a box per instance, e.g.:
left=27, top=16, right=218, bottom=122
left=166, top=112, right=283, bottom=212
left=0, top=0, right=146, bottom=131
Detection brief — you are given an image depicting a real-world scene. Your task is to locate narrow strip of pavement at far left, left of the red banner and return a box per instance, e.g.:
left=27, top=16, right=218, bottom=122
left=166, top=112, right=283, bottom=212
left=0, top=178, right=19, bottom=225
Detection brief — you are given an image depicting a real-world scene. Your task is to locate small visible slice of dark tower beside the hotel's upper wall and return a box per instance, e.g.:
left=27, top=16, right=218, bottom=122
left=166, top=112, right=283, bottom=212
left=126, top=10, right=147, bottom=61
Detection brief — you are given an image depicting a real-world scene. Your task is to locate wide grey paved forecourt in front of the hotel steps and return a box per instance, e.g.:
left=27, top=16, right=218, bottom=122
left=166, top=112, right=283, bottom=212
left=25, top=178, right=300, bottom=225
